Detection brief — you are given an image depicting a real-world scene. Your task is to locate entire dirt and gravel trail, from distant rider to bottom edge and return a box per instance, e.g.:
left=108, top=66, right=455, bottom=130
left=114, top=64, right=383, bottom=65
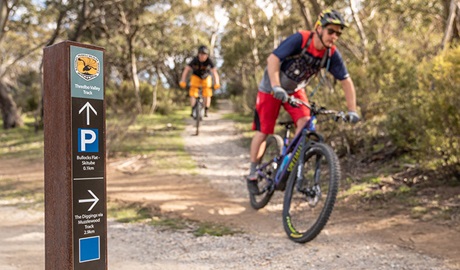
left=0, top=102, right=460, bottom=270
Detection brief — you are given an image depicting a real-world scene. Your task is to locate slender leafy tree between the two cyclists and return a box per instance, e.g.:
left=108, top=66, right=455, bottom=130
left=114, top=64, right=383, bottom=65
left=221, top=0, right=273, bottom=111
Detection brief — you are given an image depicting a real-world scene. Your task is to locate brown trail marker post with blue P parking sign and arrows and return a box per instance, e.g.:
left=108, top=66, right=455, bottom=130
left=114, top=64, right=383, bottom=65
left=43, top=41, right=107, bottom=270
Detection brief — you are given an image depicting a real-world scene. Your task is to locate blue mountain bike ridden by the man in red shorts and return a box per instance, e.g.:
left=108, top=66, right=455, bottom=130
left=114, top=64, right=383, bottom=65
left=249, top=97, right=347, bottom=243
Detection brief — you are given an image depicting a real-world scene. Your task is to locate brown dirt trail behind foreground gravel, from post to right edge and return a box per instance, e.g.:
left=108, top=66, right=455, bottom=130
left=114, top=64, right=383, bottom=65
left=109, top=101, right=460, bottom=269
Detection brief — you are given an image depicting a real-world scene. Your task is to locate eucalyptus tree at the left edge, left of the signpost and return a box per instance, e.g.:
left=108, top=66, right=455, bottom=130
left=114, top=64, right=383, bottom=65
left=0, top=0, right=54, bottom=129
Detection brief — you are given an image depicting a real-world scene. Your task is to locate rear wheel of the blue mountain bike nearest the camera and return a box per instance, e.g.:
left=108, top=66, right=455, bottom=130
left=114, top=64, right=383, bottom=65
left=249, top=134, right=283, bottom=209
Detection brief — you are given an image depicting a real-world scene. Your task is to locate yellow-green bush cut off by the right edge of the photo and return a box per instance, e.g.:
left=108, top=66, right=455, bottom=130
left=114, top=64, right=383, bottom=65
left=414, top=46, right=460, bottom=173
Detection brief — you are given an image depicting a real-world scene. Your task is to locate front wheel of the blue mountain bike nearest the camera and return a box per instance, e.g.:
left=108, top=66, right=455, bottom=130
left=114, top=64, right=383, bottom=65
left=283, top=143, right=340, bottom=243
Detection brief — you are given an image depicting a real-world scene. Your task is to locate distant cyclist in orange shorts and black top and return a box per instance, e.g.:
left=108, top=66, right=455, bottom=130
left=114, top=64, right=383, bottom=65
left=179, top=45, right=220, bottom=117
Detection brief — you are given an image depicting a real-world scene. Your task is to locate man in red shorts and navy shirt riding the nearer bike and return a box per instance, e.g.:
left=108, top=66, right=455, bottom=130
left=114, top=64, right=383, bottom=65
left=246, top=9, right=359, bottom=194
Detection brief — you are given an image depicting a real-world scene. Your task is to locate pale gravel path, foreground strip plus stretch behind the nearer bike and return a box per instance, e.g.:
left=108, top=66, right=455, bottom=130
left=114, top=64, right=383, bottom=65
left=0, top=100, right=454, bottom=270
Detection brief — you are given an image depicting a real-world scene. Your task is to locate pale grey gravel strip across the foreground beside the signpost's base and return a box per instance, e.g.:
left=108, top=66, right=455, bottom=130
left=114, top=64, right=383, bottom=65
left=0, top=205, right=448, bottom=270
